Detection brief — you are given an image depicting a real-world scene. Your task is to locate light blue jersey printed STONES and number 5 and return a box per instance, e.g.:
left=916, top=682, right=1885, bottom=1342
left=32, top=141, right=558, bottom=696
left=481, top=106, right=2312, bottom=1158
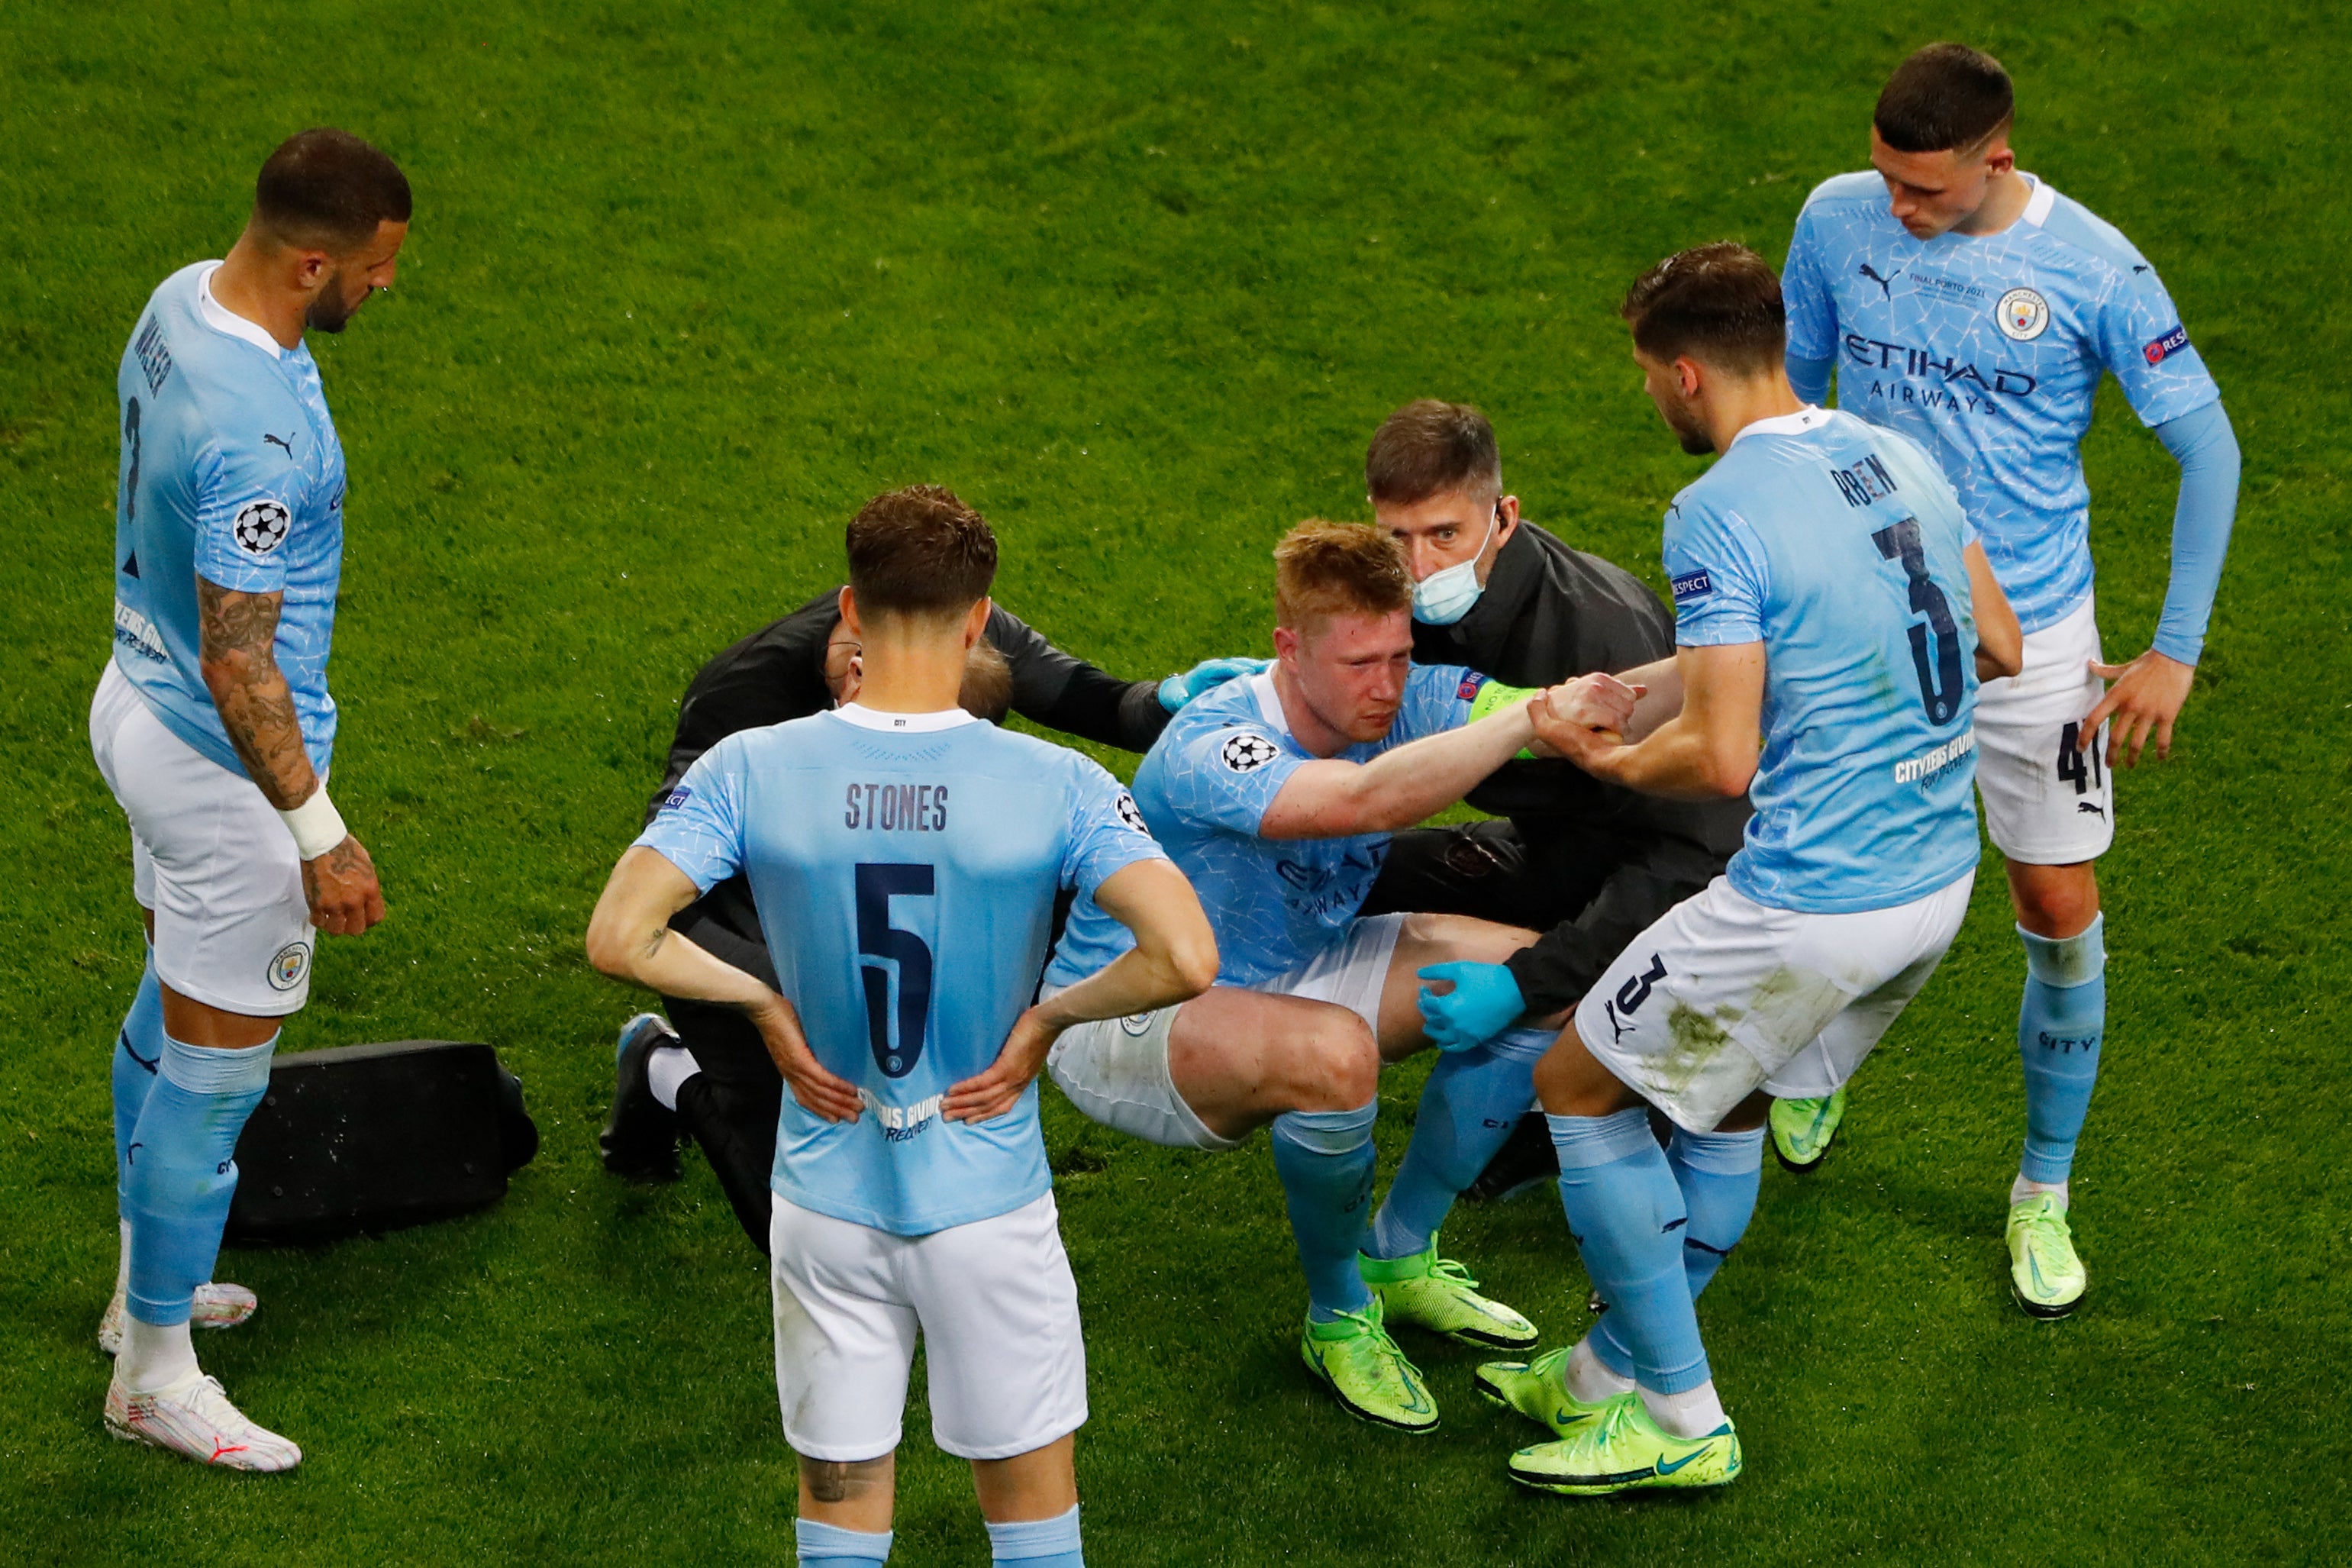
left=637, top=705, right=1162, bottom=1237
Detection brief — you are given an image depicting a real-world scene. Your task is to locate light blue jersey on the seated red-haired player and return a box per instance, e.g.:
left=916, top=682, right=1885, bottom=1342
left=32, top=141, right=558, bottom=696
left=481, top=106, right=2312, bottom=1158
left=1047, top=665, right=1486, bottom=985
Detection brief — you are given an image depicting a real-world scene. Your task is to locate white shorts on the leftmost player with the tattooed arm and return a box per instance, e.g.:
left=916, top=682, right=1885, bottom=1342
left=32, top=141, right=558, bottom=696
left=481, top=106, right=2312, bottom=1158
left=89, top=658, right=318, bottom=1018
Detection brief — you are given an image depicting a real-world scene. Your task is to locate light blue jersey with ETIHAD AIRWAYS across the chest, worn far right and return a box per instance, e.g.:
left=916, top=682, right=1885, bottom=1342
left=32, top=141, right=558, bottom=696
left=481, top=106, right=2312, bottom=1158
left=1780, top=174, right=2220, bottom=632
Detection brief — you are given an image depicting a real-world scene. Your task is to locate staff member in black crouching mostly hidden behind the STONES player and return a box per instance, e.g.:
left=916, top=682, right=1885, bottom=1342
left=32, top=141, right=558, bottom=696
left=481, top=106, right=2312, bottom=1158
left=600, top=576, right=1230, bottom=1253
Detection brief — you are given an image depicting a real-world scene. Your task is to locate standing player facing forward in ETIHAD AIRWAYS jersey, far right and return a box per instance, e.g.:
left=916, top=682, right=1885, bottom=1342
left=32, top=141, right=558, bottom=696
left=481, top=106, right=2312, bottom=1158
left=1773, top=45, right=2239, bottom=1316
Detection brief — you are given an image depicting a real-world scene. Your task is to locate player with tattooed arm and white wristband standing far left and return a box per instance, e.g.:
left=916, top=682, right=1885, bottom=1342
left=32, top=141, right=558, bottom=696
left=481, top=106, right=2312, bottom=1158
left=89, top=129, right=409, bottom=1470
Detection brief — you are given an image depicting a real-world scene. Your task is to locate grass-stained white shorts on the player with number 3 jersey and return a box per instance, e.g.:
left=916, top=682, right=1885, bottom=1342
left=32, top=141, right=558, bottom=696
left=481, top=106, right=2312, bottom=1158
left=1576, top=869, right=1976, bottom=1133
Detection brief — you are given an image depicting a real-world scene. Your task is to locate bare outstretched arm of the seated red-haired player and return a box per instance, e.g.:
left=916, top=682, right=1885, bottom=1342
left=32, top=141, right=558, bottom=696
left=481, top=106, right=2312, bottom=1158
left=1258, top=696, right=1543, bottom=839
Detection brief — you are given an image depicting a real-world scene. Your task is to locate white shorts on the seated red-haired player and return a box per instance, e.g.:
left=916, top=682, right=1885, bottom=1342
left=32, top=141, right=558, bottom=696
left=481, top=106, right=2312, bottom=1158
left=1044, top=915, right=1404, bottom=1152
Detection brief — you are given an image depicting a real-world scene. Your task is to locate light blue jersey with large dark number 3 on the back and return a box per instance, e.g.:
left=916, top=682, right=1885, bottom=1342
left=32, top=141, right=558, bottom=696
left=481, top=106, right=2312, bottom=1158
left=1665, top=409, right=1976, bottom=915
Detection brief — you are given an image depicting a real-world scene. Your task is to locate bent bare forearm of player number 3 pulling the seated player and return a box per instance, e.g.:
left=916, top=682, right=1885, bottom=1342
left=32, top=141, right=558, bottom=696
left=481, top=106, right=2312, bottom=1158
left=1536, top=642, right=1764, bottom=799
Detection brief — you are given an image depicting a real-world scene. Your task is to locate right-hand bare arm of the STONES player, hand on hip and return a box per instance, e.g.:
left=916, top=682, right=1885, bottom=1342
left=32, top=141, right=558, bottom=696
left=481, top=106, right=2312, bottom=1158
left=938, top=858, right=1216, bottom=1121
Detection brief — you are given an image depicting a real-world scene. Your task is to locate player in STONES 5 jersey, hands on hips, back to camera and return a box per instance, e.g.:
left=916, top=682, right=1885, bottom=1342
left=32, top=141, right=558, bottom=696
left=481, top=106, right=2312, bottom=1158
left=588, top=484, right=1216, bottom=1568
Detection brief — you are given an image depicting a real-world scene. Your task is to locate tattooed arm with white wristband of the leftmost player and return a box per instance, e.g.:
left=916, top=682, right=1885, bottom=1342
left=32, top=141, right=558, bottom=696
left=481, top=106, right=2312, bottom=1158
left=195, top=576, right=383, bottom=936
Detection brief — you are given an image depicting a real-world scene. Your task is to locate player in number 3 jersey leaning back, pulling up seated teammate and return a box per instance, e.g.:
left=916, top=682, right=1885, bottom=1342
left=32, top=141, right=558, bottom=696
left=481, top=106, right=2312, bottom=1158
left=1477, top=244, right=2021, bottom=1495
